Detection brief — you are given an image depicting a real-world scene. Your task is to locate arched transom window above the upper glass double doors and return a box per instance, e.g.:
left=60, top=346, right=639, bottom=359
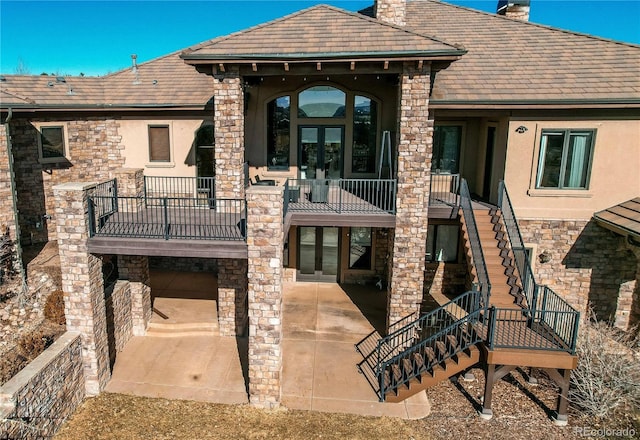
left=298, top=86, right=347, bottom=118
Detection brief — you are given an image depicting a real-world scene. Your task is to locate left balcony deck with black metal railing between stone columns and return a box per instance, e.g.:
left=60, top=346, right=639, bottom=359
left=89, top=192, right=247, bottom=258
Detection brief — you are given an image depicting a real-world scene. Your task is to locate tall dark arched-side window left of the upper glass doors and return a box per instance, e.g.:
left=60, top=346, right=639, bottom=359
left=267, top=96, right=291, bottom=170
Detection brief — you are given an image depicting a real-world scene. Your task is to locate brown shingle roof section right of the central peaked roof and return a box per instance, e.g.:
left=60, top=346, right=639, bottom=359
left=406, top=0, right=640, bottom=105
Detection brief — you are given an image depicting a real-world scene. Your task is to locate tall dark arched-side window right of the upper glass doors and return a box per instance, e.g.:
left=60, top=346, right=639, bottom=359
left=351, top=95, right=378, bottom=173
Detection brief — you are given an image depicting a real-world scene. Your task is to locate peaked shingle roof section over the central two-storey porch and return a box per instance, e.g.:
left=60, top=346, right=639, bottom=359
left=183, top=5, right=464, bottom=60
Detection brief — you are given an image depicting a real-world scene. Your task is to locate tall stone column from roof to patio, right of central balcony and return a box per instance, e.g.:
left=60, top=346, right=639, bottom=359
left=387, top=63, right=433, bottom=327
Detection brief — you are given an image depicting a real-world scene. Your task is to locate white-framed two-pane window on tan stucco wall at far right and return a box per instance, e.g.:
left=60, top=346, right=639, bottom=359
left=536, top=130, right=595, bottom=189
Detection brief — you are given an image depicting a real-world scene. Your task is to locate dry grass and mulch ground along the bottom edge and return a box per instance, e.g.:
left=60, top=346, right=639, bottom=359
left=55, top=370, right=640, bottom=440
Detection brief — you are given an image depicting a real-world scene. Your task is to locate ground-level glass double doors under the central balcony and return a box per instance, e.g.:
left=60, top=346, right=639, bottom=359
left=297, top=226, right=339, bottom=282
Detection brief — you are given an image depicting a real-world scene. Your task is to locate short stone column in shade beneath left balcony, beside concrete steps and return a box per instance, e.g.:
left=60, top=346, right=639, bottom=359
left=118, top=255, right=153, bottom=336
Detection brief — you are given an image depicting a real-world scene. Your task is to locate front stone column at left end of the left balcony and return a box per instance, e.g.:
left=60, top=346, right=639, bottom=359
left=53, top=183, right=111, bottom=395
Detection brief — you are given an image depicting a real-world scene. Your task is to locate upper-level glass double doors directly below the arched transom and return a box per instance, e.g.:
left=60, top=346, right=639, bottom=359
left=299, top=126, right=344, bottom=179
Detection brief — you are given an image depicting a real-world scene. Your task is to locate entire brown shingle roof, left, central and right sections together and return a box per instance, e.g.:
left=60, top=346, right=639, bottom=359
left=0, top=0, right=640, bottom=108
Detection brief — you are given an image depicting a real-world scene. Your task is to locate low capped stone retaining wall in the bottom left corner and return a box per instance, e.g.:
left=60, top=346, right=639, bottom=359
left=0, top=332, right=85, bottom=440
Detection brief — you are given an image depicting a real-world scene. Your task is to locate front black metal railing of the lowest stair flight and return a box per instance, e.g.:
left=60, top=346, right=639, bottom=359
left=376, top=291, right=484, bottom=401
